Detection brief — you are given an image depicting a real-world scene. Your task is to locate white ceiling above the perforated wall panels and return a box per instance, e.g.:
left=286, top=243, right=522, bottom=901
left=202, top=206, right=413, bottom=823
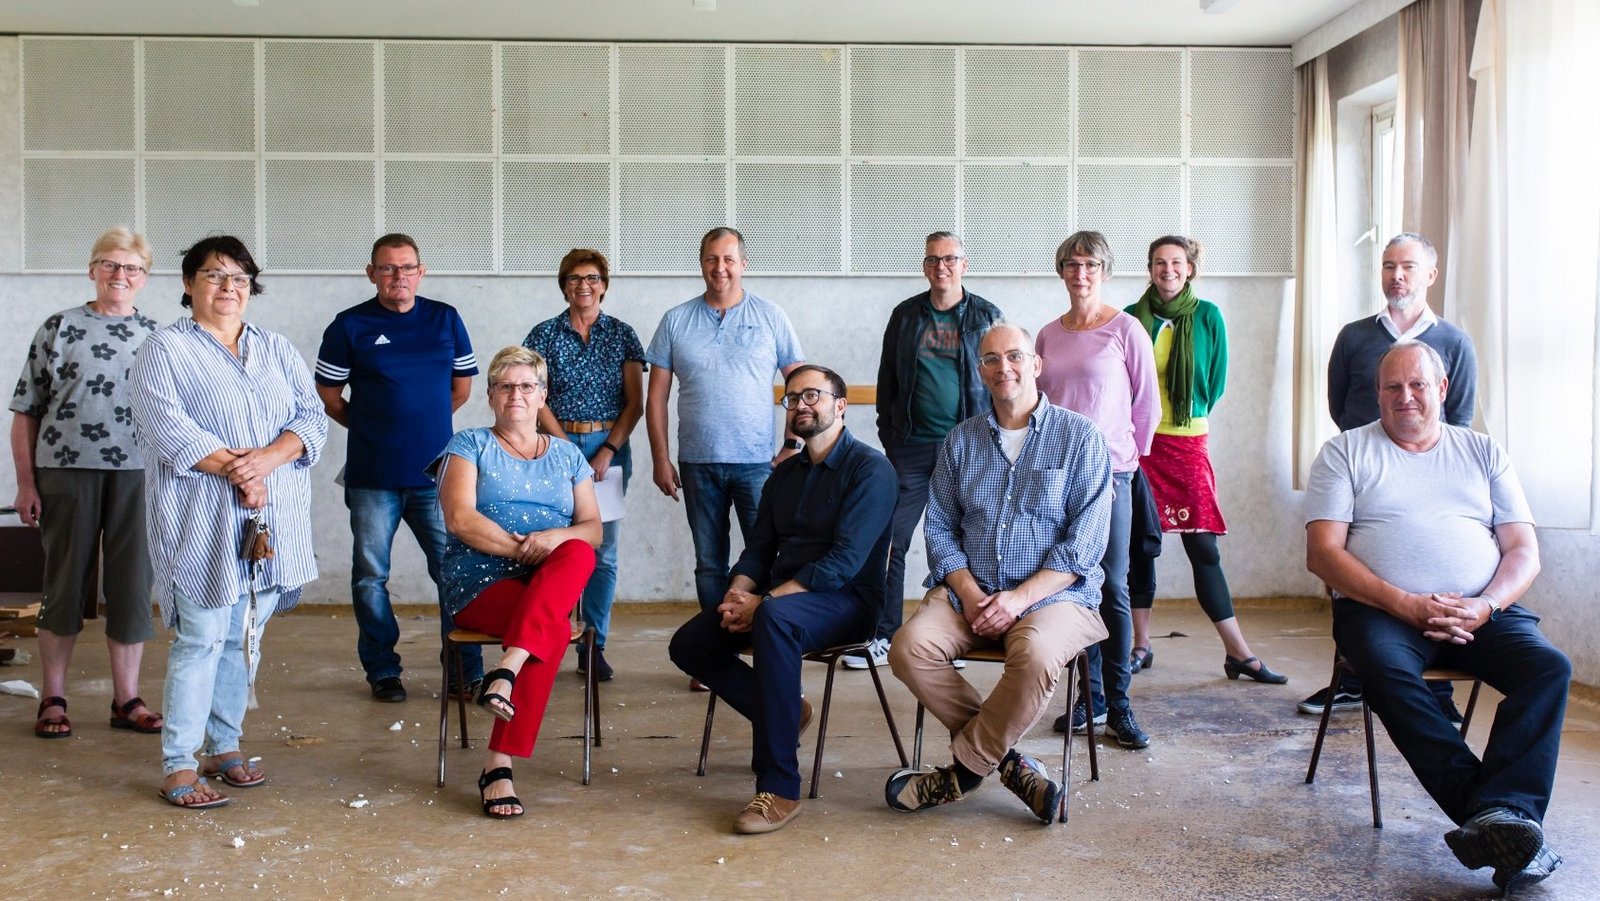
left=0, top=0, right=1360, bottom=46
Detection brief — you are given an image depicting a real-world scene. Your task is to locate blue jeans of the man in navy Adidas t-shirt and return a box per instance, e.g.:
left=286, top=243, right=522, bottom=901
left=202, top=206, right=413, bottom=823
left=344, top=487, right=483, bottom=685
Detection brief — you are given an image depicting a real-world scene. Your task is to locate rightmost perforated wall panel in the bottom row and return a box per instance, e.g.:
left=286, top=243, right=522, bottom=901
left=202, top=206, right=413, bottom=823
left=1189, top=166, right=1294, bottom=275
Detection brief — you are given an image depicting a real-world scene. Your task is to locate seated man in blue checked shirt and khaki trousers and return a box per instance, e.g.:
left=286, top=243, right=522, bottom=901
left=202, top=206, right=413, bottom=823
left=883, top=322, right=1112, bottom=823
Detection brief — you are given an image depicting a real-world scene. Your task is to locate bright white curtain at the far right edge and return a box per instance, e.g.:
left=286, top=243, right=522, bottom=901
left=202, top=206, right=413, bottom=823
left=1453, top=0, right=1600, bottom=528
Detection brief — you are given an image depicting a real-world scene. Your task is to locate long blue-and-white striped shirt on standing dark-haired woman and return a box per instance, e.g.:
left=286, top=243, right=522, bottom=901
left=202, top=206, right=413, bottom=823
left=128, top=318, right=328, bottom=626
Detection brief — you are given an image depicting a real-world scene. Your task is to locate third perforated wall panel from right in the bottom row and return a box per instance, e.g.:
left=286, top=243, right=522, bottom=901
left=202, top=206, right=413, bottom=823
left=962, top=165, right=1072, bottom=272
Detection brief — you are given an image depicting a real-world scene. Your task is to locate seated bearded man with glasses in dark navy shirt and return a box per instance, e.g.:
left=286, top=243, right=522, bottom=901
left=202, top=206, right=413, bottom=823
left=670, top=365, right=894, bottom=834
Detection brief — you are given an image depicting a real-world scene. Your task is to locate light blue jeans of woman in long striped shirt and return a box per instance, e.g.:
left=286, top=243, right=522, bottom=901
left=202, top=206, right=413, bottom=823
left=162, top=587, right=278, bottom=776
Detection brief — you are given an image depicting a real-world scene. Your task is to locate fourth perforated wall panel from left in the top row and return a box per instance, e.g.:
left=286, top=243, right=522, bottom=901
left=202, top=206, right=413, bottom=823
left=382, top=42, right=494, bottom=154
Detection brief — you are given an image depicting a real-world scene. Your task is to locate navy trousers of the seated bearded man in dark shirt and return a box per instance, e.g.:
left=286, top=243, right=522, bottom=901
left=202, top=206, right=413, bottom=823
left=667, top=592, right=878, bottom=800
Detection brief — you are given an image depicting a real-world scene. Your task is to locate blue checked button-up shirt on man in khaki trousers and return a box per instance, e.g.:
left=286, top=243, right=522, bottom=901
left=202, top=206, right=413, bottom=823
left=923, top=394, right=1112, bottom=616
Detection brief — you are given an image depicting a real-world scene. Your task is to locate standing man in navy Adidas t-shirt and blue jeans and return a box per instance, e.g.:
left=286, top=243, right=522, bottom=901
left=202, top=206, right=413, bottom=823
left=317, top=234, right=483, bottom=703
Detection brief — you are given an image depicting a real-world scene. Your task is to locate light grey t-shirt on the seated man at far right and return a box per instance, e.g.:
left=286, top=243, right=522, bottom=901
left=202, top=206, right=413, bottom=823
left=1306, top=422, right=1533, bottom=597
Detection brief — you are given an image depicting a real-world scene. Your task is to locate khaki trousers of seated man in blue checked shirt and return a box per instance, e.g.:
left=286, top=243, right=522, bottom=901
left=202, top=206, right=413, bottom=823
left=890, top=586, right=1106, bottom=776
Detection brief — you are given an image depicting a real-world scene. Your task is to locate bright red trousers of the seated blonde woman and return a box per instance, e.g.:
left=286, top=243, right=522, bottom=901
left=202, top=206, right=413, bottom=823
left=456, top=538, right=595, bottom=757
